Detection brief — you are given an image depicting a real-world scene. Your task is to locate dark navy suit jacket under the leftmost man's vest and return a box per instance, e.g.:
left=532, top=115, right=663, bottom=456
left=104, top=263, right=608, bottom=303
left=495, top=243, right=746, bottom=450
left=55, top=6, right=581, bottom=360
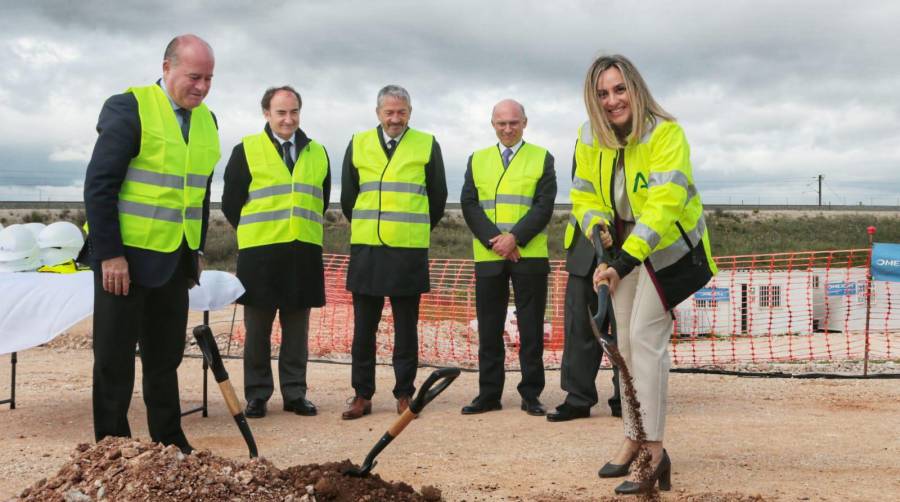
left=82, top=82, right=215, bottom=287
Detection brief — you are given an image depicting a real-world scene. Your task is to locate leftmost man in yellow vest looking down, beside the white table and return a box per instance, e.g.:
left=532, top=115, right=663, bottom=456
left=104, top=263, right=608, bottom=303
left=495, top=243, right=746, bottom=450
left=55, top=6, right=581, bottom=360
left=84, top=35, right=219, bottom=452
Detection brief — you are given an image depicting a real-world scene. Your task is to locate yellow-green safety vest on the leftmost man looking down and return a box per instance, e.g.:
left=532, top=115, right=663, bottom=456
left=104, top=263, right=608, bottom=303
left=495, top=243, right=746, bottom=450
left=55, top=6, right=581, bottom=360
left=118, top=85, right=220, bottom=253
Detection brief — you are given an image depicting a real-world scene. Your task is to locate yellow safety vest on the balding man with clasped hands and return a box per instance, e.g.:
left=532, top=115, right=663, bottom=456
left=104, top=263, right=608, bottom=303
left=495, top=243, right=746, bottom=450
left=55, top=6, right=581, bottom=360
left=472, top=143, right=549, bottom=262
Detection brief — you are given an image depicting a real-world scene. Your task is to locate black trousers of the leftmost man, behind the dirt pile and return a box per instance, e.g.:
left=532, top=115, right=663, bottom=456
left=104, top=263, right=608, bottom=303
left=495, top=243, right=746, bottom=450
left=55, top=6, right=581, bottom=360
left=93, top=260, right=188, bottom=446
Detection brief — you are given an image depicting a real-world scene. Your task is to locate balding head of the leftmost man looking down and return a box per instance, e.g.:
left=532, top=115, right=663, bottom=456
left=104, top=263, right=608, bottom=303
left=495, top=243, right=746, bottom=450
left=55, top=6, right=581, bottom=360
left=163, top=35, right=216, bottom=110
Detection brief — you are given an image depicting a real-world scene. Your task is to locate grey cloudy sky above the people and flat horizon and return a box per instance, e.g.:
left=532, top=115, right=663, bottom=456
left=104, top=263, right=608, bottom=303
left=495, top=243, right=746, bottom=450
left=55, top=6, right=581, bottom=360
left=0, top=0, right=900, bottom=205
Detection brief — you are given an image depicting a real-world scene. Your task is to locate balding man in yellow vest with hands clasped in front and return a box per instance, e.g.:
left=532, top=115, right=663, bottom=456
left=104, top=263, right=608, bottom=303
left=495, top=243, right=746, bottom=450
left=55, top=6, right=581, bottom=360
left=460, top=99, right=556, bottom=416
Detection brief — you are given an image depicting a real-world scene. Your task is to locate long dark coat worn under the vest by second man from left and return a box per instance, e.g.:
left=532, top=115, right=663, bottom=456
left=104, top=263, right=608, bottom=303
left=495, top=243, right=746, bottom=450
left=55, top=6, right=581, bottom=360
left=222, top=124, right=331, bottom=309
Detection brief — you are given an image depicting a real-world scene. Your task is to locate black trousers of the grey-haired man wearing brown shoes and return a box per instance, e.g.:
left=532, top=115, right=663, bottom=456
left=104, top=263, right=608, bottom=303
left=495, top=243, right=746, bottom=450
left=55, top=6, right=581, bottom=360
left=350, top=293, right=421, bottom=399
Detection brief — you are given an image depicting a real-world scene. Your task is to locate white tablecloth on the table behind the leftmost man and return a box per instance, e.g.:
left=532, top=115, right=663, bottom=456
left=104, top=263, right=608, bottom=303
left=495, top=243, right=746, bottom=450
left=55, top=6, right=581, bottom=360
left=0, top=270, right=244, bottom=354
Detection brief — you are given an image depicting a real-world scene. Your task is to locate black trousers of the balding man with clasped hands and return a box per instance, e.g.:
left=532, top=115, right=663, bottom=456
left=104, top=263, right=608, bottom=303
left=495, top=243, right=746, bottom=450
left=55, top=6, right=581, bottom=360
left=475, top=268, right=547, bottom=401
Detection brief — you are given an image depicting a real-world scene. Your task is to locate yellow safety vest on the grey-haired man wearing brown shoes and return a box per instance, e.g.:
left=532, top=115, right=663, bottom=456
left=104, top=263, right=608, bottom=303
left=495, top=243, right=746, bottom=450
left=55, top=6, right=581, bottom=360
left=350, top=129, right=434, bottom=249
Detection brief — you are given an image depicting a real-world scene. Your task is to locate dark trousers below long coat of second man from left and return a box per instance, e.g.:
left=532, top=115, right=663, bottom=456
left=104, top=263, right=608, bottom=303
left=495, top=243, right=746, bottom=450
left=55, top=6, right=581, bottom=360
left=244, top=305, right=309, bottom=403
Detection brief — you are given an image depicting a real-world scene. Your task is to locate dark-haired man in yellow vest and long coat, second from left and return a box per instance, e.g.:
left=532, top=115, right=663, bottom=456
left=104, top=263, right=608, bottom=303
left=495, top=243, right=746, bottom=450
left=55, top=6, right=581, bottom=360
left=222, top=85, right=331, bottom=418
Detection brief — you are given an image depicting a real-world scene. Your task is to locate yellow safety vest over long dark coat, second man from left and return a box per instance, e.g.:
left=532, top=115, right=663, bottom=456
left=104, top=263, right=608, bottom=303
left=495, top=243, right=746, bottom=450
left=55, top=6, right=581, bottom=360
left=237, top=132, right=328, bottom=249
